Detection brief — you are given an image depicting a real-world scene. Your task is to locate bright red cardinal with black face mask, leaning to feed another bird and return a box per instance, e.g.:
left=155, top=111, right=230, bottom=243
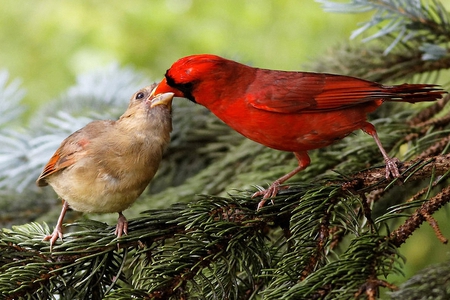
left=152, top=54, right=445, bottom=209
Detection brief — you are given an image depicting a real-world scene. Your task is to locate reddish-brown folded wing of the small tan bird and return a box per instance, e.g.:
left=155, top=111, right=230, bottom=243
left=36, top=121, right=113, bottom=186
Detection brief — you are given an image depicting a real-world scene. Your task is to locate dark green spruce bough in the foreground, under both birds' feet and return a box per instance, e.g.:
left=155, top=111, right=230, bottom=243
left=0, top=147, right=448, bottom=299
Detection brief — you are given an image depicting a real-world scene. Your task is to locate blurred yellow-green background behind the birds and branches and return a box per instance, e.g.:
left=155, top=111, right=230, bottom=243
left=0, top=0, right=450, bottom=290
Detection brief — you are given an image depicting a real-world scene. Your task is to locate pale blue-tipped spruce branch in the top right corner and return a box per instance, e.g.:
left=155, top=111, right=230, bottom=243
left=318, top=0, right=450, bottom=52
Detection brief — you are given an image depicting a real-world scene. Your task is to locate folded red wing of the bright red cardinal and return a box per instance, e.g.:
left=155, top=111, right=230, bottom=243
left=247, top=70, right=387, bottom=113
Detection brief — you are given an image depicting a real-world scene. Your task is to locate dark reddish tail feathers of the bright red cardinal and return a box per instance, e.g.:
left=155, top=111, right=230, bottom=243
left=383, top=83, right=447, bottom=103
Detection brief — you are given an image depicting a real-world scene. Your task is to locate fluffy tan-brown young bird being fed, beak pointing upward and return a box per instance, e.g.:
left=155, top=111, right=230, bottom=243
left=36, top=85, right=174, bottom=251
